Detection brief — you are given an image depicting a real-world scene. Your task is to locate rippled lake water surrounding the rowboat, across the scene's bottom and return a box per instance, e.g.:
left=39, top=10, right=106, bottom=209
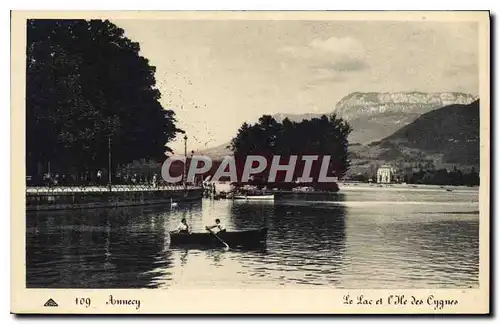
left=26, top=187, right=479, bottom=289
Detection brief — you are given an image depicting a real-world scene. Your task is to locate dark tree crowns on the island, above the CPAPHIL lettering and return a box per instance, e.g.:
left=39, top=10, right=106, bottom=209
left=230, top=114, right=351, bottom=177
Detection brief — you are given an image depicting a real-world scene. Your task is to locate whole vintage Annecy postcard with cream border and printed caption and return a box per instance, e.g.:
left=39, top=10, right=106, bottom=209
left=11, top=11, right=490, bottom=314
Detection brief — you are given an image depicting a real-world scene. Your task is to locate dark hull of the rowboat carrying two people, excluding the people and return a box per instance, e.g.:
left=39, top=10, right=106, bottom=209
left=170, top=228, right=267, bottom=248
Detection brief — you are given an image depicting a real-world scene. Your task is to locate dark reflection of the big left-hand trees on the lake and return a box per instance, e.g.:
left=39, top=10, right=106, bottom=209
left=26, top=209, right=173, bottom=288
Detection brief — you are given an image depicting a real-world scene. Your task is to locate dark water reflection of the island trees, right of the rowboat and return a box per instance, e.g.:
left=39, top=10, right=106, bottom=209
left=270, top=202, right=346, bottom=284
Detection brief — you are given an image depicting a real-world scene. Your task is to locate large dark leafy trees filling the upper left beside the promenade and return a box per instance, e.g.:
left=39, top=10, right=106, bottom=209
left=26, top=19, right=180, bottom=180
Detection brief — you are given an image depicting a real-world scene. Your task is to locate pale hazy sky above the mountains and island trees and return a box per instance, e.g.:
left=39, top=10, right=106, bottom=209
left=113, top=20, right=479, bottom=150
